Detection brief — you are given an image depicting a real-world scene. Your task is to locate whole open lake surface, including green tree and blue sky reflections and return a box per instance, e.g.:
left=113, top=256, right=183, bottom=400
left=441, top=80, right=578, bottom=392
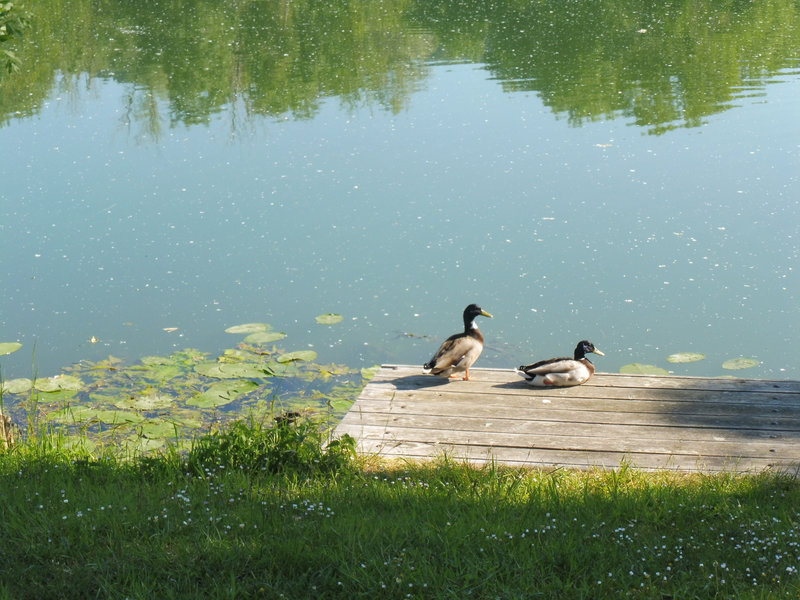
left=0, top=1, right=800, bottom=379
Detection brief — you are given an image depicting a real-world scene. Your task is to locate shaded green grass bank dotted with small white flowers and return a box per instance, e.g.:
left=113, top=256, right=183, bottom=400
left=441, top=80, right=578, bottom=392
left=0, top=420, right=800, bottom=600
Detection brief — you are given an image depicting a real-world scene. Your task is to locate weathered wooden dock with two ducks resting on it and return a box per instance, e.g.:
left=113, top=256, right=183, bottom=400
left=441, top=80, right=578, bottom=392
left=335, top=365, right=800, bottom=473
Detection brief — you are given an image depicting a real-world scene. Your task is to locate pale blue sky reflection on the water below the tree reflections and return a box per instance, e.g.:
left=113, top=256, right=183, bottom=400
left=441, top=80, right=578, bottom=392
left=0, top=59, right=800, bottom=378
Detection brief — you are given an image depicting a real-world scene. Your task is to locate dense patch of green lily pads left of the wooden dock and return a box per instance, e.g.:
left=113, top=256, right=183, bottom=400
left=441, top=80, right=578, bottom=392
left=3, top=323, right=378, bottom=454
